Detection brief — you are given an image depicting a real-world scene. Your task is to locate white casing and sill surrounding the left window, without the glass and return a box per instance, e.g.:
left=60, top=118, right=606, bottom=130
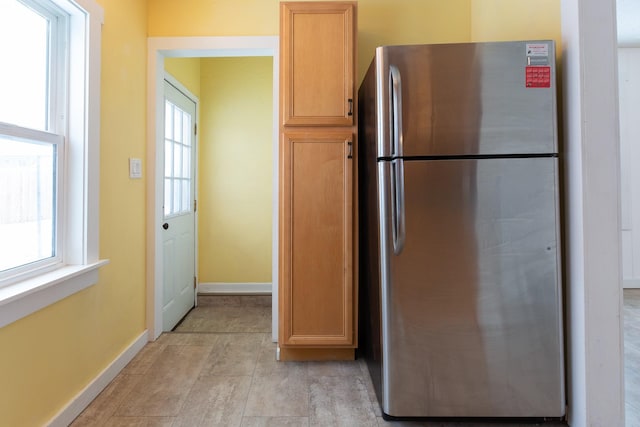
left=0, top=0, right=108, bottom=327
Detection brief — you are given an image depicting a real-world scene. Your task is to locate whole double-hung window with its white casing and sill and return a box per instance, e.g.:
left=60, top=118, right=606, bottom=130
left=0, top=0, right=104, bottom=327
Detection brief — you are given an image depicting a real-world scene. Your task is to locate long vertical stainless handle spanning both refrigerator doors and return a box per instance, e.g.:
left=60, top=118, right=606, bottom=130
left=389, top=65, right=406, bottom=255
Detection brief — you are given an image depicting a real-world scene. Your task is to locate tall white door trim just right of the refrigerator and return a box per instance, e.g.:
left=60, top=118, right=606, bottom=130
left=560, top=0, right=625, bottom=427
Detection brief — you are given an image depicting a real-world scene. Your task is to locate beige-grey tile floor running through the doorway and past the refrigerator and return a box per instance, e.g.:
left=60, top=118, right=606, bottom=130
left=72, top=290, right=640, bottom=427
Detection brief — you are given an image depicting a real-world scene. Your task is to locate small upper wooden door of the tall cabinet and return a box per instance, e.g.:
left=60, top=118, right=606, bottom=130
left=280, top=2, right=356, bottom=126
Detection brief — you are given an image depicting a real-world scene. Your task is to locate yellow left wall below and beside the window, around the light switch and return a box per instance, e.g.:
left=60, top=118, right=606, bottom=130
left=0, top=0, right=146, bottom=426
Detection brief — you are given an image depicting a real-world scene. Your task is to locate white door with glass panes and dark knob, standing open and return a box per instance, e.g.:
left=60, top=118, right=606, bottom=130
left=162, top=80, right=196, bottom=331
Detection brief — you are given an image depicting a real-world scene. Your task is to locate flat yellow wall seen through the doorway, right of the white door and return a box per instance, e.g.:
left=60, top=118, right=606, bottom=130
left=198, top=57, right=273, bottom=283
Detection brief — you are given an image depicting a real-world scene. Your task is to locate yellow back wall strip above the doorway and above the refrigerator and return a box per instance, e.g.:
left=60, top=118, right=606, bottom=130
left=148, top=0, right=472, bottom=87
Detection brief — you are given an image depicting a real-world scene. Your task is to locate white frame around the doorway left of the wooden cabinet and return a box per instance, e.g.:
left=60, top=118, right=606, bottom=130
left=146, top=36, right=280, bottom=342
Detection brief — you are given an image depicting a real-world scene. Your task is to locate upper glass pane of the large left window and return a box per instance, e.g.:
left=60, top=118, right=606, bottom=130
left=0, top=0, right=49, bottom=130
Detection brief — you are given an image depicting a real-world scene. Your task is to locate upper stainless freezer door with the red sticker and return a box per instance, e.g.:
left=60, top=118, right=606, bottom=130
left=372, top=41, right=558, bottom=157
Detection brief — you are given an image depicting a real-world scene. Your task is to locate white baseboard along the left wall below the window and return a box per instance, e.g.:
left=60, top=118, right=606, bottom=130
left=47, top=330, right=148, bottom=427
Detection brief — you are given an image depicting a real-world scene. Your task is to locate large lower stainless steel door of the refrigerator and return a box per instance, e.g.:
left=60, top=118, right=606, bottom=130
left=378, top=158, right=565, bottom=417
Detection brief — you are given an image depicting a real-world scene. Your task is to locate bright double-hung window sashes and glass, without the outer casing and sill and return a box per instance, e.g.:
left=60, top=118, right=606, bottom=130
left=0, top=0, right=68, bottom=281
